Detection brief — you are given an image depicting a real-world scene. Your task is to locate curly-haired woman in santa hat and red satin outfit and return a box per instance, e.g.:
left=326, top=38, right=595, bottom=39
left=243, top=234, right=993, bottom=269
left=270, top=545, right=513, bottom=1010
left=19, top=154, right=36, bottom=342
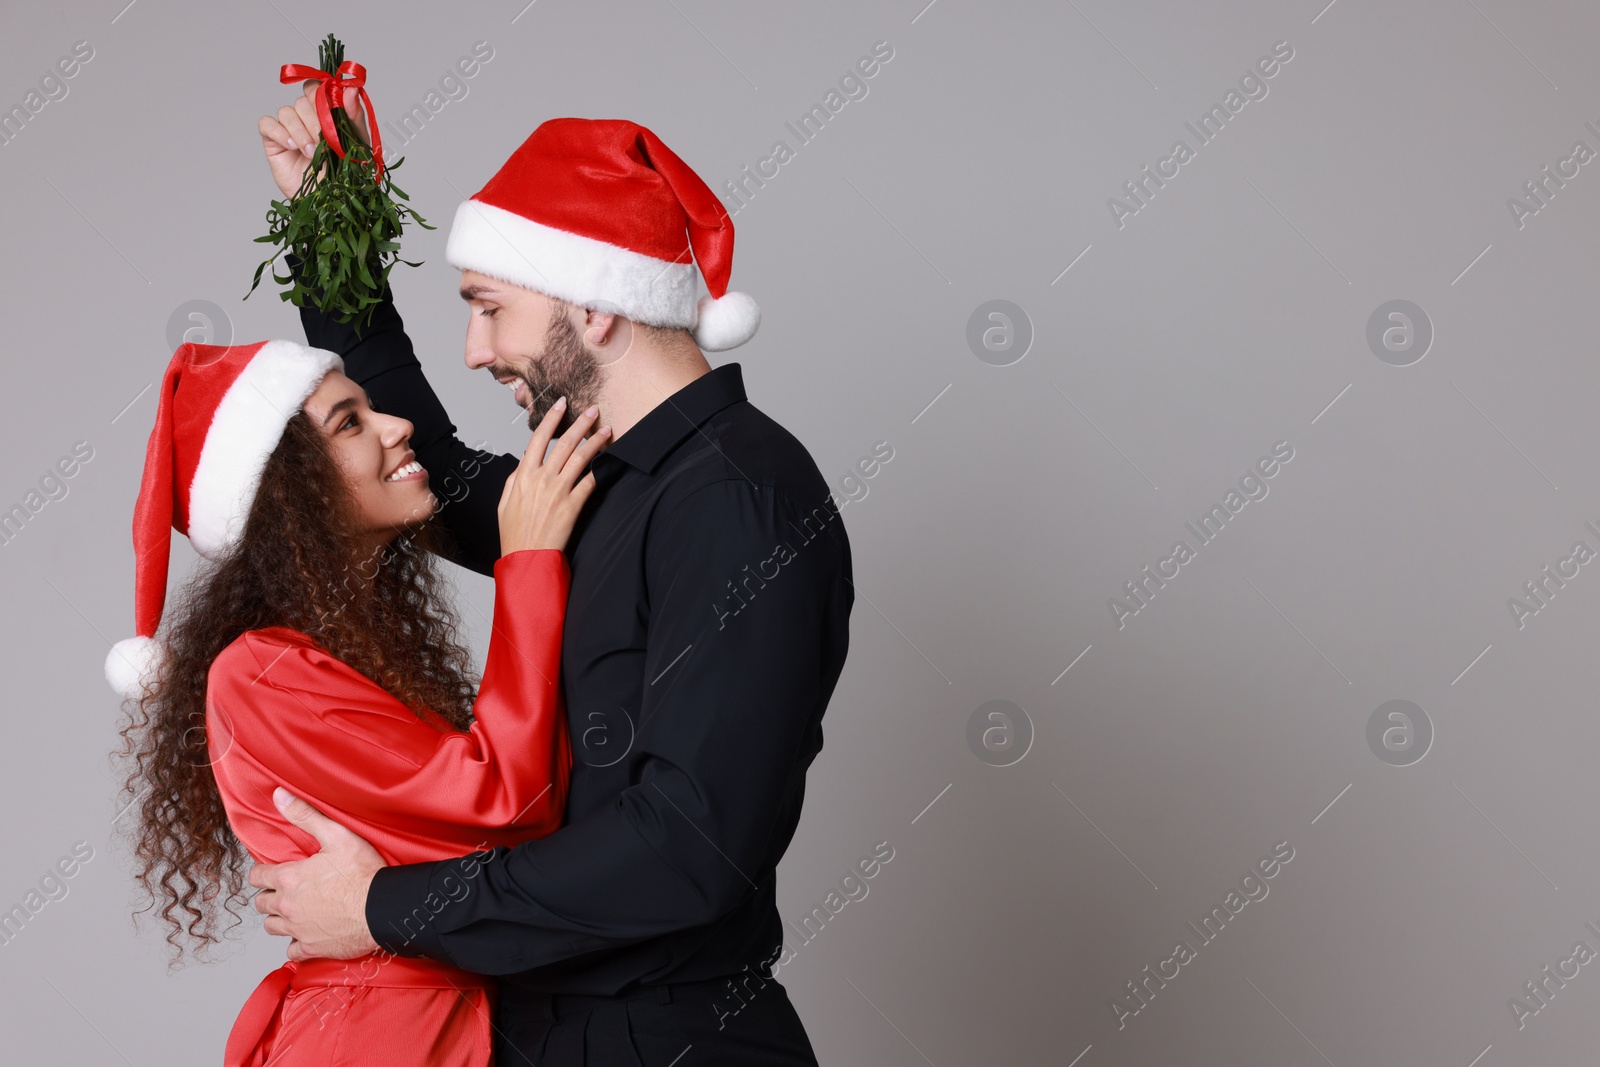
left=107, top=341, right=608, bottom=1067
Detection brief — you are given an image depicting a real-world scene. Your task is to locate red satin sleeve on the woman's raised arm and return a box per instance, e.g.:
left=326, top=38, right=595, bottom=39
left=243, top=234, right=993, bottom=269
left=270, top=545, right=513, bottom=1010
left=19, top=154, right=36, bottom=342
left=208, top=549, right=571, bottom=843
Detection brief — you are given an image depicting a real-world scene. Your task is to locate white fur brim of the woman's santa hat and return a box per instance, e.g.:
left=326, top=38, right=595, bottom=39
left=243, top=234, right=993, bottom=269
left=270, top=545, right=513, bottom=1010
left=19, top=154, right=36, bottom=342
left=189, top=341, right=344, bottom=560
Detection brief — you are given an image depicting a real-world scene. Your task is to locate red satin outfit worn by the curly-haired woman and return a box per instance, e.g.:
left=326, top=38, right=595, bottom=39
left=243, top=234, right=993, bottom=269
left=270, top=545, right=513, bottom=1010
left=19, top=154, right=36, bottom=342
left=206, top=549, right=573, bottom=1067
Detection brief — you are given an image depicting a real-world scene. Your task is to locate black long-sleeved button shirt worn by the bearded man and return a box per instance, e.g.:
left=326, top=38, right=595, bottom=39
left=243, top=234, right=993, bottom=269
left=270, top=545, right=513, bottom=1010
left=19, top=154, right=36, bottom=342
left=301, top=287, right=854, bottom=1009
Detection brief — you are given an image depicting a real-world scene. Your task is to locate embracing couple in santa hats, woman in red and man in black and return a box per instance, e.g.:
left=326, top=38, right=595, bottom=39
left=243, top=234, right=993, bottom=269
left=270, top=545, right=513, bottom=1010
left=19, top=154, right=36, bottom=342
left=107, top=79, right=854, bottom=1067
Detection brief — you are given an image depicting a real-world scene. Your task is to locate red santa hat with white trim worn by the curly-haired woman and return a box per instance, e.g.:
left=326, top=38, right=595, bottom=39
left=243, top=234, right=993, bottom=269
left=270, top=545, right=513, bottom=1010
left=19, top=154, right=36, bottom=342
left=106, top=341, right=344, bottom=699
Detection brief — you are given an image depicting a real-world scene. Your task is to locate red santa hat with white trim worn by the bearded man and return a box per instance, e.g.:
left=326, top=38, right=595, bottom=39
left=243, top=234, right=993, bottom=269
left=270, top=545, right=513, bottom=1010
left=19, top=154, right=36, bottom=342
left=445, top=118, right=762, bottom=352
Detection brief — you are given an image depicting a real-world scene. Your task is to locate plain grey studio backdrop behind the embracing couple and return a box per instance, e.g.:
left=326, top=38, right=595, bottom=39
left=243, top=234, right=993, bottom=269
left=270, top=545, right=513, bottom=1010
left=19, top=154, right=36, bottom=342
left=0, top=0, right=1600, bottom=1067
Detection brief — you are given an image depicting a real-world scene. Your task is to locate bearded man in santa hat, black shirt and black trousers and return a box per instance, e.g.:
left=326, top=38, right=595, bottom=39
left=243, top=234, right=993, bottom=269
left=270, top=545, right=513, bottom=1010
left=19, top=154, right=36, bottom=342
left=251, top=88, right=854, bottom=1067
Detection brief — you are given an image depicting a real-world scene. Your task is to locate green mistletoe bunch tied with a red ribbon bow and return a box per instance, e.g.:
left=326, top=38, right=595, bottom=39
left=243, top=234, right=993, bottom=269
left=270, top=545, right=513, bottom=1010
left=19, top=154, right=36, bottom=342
left=245, top=34, right=437, bottom=330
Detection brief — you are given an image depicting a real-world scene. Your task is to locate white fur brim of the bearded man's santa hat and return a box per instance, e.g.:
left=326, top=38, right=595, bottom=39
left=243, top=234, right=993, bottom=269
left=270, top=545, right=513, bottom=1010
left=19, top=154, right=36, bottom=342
left=445, top=200, right=699, bottom=326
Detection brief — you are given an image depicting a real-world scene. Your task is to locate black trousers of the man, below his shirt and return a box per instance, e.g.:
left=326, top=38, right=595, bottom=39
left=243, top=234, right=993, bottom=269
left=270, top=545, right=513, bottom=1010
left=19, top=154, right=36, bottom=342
left=494, top=974, right=816, bottom=1067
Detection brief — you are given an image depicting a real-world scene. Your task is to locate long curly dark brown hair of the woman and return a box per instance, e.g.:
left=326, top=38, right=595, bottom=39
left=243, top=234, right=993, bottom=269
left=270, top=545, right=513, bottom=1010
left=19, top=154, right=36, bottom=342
left=118, top=413, right=477, bottom=966
